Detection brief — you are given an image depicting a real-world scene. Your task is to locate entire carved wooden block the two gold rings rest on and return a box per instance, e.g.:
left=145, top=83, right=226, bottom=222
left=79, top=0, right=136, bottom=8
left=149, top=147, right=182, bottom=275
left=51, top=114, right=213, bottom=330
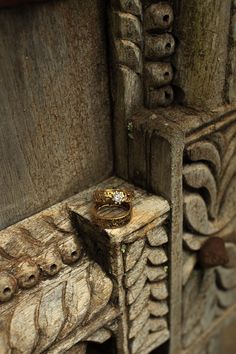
left=70, top=179, right=169, bottom=354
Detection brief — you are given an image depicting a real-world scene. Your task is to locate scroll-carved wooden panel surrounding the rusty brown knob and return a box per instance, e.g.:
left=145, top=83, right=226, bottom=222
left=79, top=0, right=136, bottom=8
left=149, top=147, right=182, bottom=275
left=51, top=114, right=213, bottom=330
left=183, top=113, right=236, bottom=348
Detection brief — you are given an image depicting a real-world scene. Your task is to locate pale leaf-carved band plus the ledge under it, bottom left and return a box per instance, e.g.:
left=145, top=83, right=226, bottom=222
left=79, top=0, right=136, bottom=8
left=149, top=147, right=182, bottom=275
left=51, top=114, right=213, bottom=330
left=0, top=260, right=118, bottom=353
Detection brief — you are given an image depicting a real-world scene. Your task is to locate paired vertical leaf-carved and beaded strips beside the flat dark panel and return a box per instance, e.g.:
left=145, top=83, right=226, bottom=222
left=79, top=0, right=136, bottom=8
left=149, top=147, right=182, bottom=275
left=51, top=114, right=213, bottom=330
left=109, top=0, right=175, bottom=179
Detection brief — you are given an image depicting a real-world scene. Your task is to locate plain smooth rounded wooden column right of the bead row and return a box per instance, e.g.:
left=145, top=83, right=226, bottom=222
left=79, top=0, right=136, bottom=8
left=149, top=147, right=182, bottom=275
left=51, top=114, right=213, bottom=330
left=174, top=0, right=232, bottom=110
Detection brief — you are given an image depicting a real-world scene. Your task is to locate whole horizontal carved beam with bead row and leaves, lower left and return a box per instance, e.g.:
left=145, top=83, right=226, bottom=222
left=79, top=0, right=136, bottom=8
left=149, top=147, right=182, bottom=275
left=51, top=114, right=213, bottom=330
left=0, top=180, right=119, bottom=354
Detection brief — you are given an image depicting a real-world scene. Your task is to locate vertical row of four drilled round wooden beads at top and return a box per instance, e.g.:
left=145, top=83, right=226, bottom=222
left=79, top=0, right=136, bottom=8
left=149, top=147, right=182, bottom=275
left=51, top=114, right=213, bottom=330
left=144, top=2, right=175, bottom=108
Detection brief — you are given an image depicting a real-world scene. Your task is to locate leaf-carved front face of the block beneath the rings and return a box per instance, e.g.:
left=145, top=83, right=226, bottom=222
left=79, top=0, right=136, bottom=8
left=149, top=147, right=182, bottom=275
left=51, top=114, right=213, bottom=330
left=121, top=226, right=169, bottom=354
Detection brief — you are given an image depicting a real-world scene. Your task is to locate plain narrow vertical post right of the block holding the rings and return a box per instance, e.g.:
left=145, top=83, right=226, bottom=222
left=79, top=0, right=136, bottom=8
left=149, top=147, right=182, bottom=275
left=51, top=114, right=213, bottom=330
left=149, top=127, right=183, bottom=354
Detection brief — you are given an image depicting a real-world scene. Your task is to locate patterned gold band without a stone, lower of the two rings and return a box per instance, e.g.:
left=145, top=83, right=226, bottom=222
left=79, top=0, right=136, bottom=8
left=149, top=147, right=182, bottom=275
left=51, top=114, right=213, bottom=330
left=92, top=202, right=132, bottom=229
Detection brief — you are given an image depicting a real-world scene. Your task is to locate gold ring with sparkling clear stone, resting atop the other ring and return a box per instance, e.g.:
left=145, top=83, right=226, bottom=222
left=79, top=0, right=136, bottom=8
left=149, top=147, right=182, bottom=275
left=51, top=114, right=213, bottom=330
left=93, top=189, right=134, bottom=204
